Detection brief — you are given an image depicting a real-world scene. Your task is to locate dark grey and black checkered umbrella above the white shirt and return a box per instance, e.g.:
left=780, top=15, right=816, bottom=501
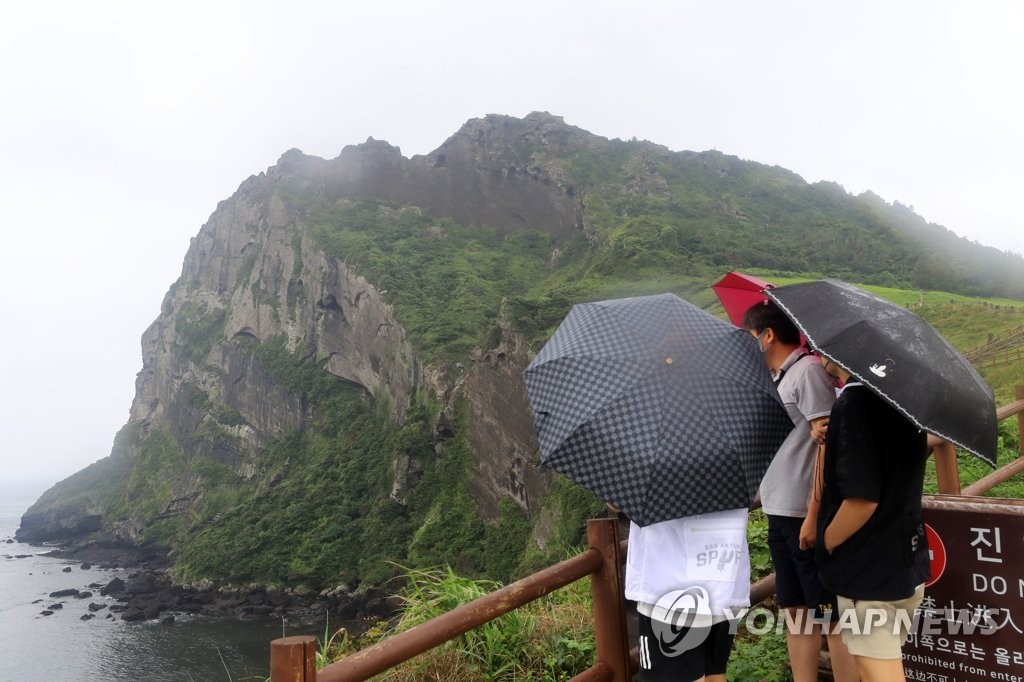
left=523, top=294, right=793, bottom=525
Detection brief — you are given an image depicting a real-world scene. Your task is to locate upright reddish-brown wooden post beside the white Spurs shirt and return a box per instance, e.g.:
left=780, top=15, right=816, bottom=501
left=587, top=518, right=632, bottom=682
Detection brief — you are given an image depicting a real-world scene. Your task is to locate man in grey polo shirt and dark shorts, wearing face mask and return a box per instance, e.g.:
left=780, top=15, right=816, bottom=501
left=742, top=301, right=858, bottom=682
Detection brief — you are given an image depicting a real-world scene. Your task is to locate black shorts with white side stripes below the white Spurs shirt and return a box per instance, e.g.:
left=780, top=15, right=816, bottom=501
left=636, top=613, right=735, bottom=682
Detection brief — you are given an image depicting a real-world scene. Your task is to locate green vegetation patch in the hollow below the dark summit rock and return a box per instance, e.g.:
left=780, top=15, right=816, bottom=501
left=311, top=201, right=553, bottom=360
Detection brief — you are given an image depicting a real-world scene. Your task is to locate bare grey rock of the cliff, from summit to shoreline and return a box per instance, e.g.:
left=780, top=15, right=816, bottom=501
left=18, top=114, right=600, bottom=581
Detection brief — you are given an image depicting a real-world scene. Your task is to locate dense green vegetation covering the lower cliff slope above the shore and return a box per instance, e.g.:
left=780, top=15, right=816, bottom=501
left=160, top=340, right=594, bottom=589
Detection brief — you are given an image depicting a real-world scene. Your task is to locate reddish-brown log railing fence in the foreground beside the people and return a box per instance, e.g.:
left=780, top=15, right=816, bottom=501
left=270, top=386, right=1024, bottom=682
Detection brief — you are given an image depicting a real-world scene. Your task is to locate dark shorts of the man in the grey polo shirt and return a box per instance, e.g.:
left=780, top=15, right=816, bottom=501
left=768, top=515, right=839, bottom=623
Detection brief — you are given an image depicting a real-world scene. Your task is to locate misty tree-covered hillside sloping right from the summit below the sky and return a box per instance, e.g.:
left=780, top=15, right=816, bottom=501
left=559, top=140, right=1024, bottom=297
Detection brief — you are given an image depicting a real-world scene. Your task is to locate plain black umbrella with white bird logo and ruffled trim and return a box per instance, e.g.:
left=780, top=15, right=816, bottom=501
left=766, top=280, right=996, bottom=466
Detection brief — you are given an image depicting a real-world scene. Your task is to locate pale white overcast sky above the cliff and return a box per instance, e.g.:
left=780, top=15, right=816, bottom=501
left=0, top=0, right=1024, bottom=482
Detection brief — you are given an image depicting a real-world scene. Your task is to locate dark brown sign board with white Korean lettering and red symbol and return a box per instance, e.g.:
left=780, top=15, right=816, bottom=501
left=903, top=496, right=1024, bottom=682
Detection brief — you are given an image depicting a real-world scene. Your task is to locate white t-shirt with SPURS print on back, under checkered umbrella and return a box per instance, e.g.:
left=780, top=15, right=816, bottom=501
left=626, top=508, right=751, bottom=627
